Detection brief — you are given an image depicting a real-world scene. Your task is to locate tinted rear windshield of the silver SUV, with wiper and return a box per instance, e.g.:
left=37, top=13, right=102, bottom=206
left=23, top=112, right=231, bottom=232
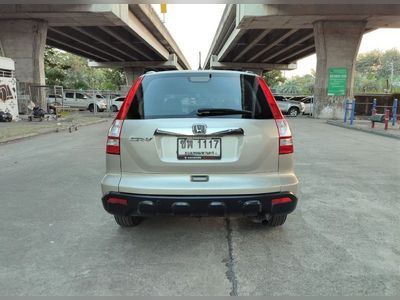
left=127, top=73, right=273, bottom=119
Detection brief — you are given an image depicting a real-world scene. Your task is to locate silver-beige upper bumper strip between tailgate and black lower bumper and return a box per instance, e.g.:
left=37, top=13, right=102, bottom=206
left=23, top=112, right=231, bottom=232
left=102, top=172, right=298, bottom=195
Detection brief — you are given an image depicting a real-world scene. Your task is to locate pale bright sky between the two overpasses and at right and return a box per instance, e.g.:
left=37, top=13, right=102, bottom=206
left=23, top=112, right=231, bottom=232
left=153, top=4, right=400, bottom=77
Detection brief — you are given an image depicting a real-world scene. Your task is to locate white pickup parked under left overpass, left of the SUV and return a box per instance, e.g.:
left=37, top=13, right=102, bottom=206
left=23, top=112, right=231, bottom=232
left=47, top=91, right=107, bottom=112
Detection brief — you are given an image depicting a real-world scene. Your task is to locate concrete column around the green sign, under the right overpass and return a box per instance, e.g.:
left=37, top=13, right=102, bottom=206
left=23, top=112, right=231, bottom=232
left=314, top=21, right=366, bottom=119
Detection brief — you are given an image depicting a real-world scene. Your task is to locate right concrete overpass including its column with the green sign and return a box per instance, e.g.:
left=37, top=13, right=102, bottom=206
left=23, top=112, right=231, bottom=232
left=204, top=0, right=400, bottom=118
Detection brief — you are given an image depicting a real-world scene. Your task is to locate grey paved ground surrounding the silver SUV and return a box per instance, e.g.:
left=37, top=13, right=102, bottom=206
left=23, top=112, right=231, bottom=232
left=0, top=119, right=400, bottom=295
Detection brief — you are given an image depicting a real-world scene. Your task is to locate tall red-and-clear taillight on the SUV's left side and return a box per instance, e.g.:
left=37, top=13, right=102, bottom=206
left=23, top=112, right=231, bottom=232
left=106, top=76, right=143, bottom=155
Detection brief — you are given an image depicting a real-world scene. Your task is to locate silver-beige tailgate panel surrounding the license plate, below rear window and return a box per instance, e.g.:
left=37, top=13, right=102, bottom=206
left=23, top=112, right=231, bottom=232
left=121, top=118, right=278, bottom=174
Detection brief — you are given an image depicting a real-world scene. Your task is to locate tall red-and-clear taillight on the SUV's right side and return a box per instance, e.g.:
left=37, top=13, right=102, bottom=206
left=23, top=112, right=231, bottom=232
left=258, top=77, right=294, bottom=155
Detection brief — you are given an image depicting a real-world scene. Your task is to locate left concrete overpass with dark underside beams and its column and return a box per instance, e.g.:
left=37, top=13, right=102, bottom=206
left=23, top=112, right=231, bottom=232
left=0, top=1, right=190, bottom=108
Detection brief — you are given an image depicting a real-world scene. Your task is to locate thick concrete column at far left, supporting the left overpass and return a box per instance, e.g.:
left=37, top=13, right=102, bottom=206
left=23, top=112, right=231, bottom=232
left=0, top=20, right=47, bottom=108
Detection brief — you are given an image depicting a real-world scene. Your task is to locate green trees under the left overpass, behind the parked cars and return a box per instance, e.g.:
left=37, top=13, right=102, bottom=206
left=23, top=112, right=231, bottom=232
left=44, top=46, right=126, bottom=90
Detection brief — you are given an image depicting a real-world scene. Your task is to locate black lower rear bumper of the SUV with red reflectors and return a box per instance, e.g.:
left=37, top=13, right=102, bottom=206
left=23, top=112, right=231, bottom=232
left=102, top=192, right=297, bottom=216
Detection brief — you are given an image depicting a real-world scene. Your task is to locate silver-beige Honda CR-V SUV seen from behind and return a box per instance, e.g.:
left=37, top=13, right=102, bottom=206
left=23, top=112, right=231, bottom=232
left=101, top=71, right=298, bottom=226
